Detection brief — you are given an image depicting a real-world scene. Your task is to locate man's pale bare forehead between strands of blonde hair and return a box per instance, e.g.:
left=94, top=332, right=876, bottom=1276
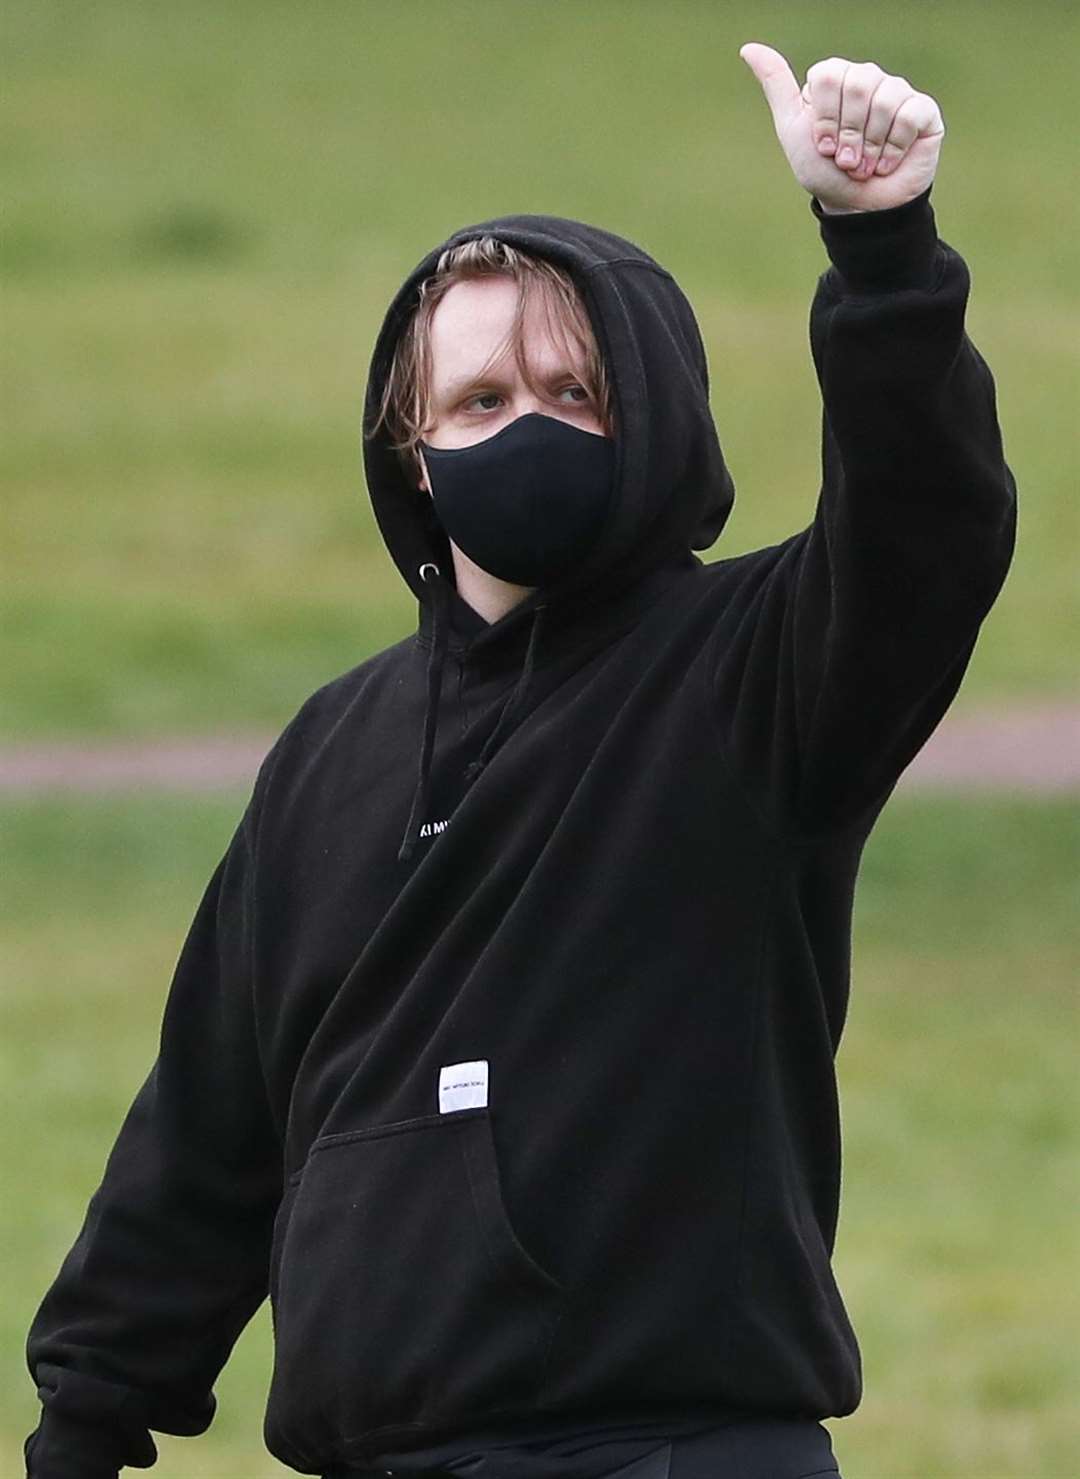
left=431, top=277, right=584, bottom=386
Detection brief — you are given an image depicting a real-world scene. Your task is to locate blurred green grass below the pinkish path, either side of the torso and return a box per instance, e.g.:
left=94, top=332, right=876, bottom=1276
left=0, top=799, right=1080, bottom=1479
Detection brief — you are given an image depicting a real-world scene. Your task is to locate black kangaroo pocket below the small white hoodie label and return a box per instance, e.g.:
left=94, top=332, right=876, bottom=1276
left=266, top=1108, right=562, bottom=1463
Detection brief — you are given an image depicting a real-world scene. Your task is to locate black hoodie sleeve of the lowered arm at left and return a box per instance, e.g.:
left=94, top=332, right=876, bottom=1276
left=25, top=768, right=283, bottom=1479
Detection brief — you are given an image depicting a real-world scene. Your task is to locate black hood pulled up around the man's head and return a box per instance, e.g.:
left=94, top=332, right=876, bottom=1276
left=364, top=216, right=735, bottom=627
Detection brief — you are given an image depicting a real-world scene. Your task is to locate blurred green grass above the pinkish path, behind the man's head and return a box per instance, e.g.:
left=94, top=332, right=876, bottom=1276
left=0, top=0, right=1080, bottom=738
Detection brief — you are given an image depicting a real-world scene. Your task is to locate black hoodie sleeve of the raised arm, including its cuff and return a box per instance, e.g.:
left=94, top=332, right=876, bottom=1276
left=712, top=188, right=1015, bottom=833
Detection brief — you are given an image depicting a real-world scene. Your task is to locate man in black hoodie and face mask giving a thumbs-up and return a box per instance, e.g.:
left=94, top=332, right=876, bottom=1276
left=28, top=44, right=1015, bottom=1479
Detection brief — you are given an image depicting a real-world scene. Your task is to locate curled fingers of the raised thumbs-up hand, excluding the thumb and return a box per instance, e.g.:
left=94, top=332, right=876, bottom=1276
left=800, top=56, right=945, bottom=179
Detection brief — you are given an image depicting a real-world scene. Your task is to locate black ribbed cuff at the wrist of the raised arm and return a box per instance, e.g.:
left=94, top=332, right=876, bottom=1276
left=811, top=185, right=939, bottom=293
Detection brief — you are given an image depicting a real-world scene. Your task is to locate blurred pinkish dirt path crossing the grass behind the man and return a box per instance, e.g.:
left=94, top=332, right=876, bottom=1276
left=0, top=703, right=1080, bottom=794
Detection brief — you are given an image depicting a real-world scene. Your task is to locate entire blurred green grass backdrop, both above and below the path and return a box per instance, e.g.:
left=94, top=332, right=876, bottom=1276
left=0, top=0, right=1080, bottom=1479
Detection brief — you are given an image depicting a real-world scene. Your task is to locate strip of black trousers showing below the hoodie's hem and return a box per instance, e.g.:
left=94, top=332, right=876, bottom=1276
left=332, top=1421, right=839, bottom=1479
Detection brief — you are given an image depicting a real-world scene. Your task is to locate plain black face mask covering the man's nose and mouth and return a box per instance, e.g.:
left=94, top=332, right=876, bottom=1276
left=420, top=411, right=615, bottom=586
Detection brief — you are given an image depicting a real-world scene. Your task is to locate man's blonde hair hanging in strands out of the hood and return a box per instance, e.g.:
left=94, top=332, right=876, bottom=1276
left=368, top=237, right=612, bottom=467
